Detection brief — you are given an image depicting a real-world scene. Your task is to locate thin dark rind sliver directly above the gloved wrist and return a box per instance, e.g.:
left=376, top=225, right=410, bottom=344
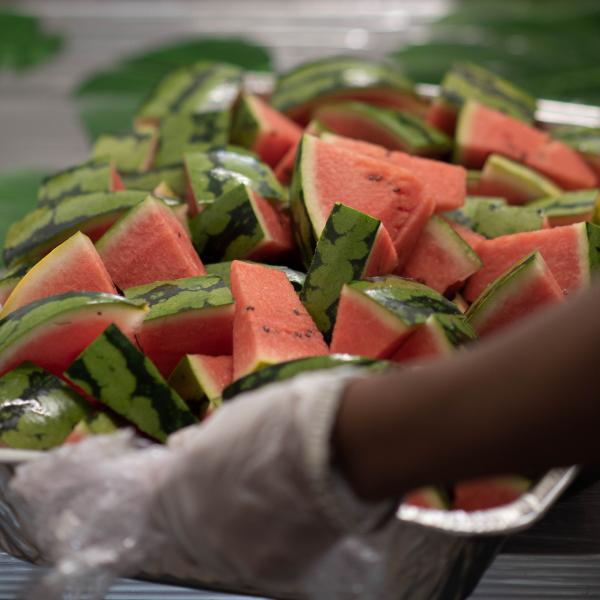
left=223, top=354, right=393, bottom=400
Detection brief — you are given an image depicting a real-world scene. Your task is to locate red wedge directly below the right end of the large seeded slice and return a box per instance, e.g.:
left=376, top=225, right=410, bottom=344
left=399, top=216, right=482, bottom=294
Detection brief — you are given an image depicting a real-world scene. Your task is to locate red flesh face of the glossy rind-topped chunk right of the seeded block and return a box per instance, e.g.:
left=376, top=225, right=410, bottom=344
left=331, top=285, right=412, bottom=358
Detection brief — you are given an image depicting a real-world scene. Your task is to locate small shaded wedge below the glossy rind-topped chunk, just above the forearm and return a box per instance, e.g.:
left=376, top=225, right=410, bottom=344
left=390, top=314, right=477, bottom=363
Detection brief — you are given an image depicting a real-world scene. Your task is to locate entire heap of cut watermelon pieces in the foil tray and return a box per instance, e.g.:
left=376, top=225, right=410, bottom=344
left=0, top=57, right=600, bottom=510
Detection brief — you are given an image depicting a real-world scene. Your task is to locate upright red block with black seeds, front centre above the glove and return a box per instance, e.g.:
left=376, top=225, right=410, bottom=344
left=231, top=260, right=329, bottom=380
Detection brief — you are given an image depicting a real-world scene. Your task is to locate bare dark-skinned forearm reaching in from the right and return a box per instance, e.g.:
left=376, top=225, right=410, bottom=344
left=333, top=283, right=600, bottom=500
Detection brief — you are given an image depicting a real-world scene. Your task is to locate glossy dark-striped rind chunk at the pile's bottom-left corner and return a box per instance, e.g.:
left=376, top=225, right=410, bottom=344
left=0, top=364, right=91, bottom=450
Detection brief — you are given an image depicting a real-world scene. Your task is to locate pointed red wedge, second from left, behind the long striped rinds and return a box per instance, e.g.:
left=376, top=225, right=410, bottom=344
left=96, top=196, right=206, bottom=290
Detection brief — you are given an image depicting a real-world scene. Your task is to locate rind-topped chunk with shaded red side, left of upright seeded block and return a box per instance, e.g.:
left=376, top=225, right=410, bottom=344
left=125, top=275, right=234, bottom=377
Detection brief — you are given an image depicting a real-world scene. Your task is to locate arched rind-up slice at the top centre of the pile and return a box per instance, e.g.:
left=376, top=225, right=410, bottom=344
left=271, top=56, right=427, bottom=125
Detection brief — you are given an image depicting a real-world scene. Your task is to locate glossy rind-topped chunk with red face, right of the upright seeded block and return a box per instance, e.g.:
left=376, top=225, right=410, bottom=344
left=331, top=276, right=461, bottom=358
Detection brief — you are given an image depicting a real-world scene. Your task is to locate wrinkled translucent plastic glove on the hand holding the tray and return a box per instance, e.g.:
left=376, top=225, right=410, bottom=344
left=13, top=369, right=395, bottom=597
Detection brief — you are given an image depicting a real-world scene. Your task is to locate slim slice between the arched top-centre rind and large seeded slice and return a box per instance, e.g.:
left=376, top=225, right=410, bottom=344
left=315, top=102, right=452, bottom=156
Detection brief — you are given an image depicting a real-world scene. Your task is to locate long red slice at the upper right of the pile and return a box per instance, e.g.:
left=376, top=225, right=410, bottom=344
left=456, top=101, right=596, bottom=190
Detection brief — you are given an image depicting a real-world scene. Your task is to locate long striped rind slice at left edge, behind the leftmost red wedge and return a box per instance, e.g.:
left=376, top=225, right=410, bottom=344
left=4, top=191, right=148, bottom=266
